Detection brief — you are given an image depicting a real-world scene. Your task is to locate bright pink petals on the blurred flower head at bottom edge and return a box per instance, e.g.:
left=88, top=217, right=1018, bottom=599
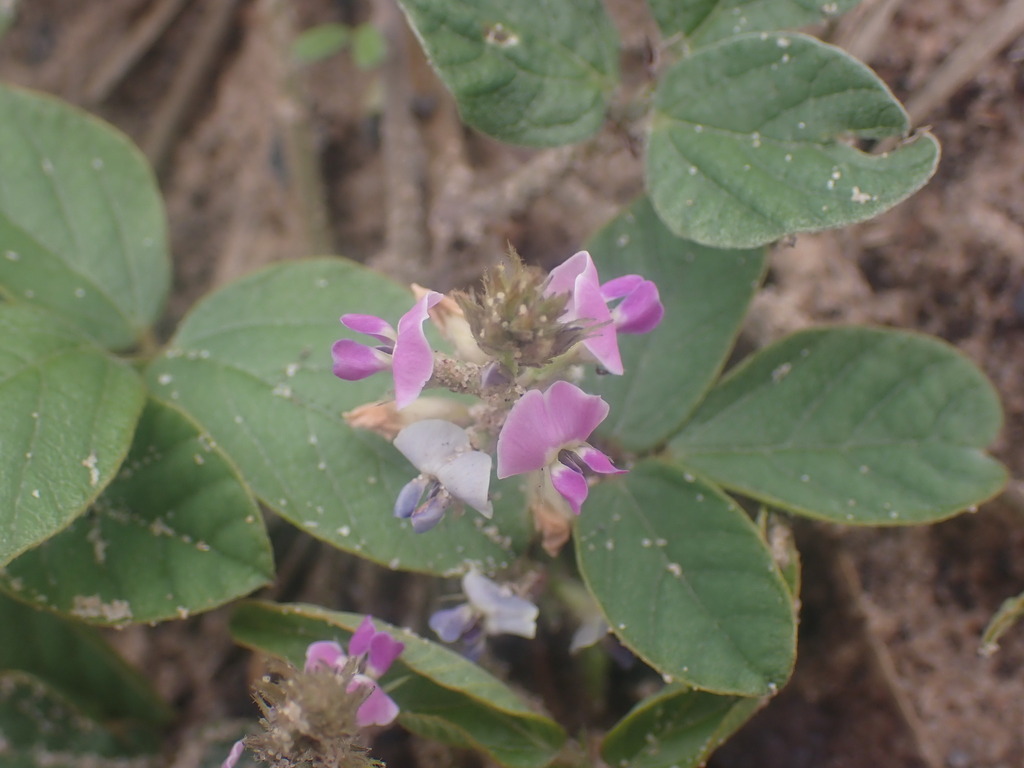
left=305, top=616, right=406, bottom=728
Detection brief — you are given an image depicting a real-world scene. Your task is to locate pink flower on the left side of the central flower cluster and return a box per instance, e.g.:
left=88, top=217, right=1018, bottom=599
left=331, top=291, right=443, bottom=408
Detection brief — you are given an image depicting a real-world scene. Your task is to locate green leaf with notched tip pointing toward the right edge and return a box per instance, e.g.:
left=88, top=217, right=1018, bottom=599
left=670, top=328, right=1006, bottom=525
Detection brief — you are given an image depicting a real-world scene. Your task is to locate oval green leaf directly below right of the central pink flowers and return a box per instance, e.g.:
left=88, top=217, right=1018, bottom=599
left=575, top=460, right=797, bottom=696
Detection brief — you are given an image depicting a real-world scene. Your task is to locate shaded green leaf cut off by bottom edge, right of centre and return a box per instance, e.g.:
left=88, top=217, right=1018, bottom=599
left=601, top=684, right=762, bottom=768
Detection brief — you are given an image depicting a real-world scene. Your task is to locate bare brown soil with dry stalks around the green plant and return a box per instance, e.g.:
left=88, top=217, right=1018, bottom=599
left=0, top=0, right=1024, bottom=768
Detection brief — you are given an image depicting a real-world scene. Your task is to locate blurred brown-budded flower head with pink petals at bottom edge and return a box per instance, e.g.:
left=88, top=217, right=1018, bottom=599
left=221, top=616, right=404, bottom=768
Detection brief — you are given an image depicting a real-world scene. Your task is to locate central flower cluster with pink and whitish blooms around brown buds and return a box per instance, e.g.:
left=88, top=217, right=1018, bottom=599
left=332, top=251, right=664, bottom=548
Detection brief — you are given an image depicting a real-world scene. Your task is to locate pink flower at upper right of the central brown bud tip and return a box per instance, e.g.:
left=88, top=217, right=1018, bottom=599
left=544, top=251, right=665, bottom=375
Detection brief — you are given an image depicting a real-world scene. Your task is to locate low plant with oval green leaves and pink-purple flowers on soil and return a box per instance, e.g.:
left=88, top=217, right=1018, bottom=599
left=0, top=0, right=1005, bottom=768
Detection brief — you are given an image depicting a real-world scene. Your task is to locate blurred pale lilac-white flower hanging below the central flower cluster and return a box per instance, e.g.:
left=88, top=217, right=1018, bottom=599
left=429, top=570, right=539, bottom=658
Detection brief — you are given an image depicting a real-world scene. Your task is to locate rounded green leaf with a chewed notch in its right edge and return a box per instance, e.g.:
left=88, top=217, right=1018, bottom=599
left=646, top=33, right=939, bottom=248
